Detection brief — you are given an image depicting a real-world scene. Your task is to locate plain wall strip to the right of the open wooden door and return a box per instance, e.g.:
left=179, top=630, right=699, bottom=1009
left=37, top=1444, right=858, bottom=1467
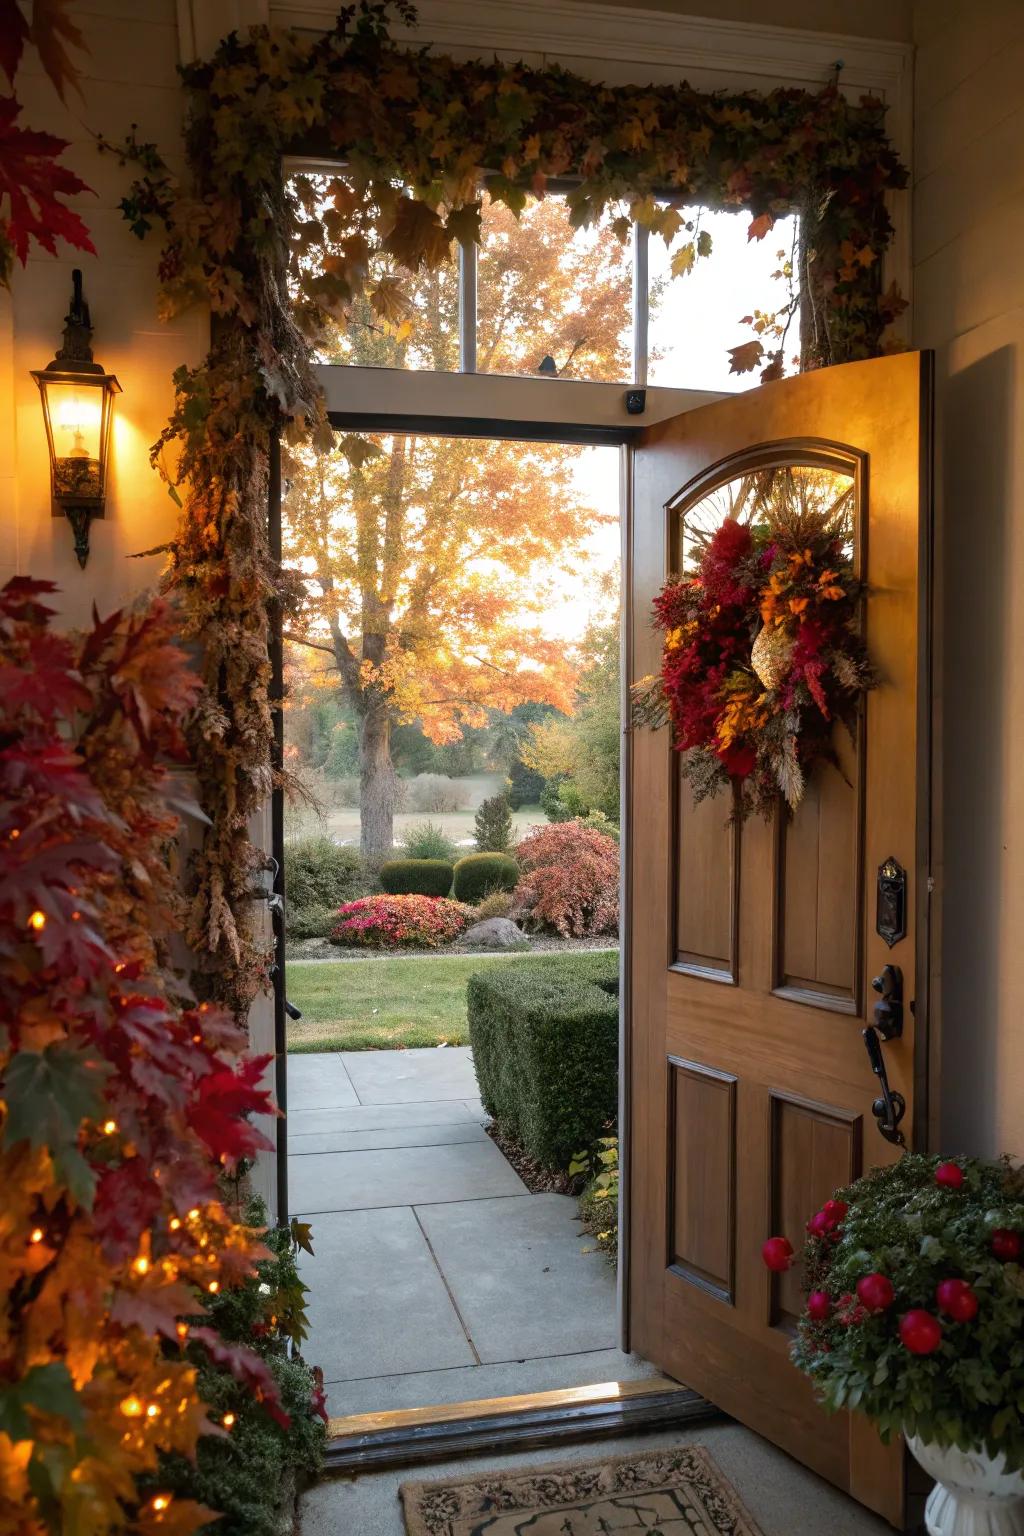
left=913, top=0, right=1024, bottom=1157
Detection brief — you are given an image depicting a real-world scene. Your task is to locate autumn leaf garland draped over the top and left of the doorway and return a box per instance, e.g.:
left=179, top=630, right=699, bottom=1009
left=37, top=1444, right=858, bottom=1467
left=107, top=0, right=906, bottom=1014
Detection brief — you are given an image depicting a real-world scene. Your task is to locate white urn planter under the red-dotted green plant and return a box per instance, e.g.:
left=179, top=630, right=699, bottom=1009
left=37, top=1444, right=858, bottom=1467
left=907, top=1435, right=1024, bottom=1536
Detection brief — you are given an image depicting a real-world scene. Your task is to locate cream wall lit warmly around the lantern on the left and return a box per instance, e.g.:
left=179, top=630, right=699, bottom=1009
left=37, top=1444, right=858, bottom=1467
left=0, top=0, right=207, bottom=624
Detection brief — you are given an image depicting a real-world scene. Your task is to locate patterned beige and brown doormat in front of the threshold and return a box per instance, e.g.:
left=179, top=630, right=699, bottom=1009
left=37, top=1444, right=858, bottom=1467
left=401, top=1445, right=761, bottom=1536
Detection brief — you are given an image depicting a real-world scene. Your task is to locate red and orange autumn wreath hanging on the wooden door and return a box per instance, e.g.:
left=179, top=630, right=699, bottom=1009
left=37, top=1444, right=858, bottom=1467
left=634, top=468, right=878, bottom=819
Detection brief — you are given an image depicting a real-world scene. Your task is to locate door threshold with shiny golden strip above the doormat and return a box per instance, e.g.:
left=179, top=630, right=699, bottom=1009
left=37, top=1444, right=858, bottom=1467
left=324, top=1376, right=723, bottom=1473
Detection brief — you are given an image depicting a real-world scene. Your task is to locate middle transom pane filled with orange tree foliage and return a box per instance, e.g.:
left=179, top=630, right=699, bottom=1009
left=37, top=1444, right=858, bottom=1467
left=476, top=195, right=633, bottom=381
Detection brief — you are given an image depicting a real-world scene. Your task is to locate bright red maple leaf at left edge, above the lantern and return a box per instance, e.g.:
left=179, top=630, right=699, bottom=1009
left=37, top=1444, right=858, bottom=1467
left=0, top=97, right=95, bottom=266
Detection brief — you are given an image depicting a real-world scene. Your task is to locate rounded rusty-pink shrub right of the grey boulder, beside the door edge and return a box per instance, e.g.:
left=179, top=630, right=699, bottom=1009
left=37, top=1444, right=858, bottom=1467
left=514, top=822, right=619, bottom=938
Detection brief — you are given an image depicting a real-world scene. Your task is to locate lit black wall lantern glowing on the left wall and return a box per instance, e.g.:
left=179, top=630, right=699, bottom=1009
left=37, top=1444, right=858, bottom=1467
left=32, top=269, right=121, bottom=568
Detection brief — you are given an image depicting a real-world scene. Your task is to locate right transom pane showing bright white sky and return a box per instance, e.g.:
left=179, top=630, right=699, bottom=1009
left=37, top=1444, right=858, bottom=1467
left=648, top=207, right=800, bottom=390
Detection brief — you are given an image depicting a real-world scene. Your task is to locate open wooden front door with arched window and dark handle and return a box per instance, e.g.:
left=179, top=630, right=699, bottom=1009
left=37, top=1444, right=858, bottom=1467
left=628, top=353, right=930, bottom=1525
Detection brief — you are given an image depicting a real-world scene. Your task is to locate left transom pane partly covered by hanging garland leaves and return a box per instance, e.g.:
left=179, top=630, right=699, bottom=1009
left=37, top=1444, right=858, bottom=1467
left=289, top=174, right=459, bottom=372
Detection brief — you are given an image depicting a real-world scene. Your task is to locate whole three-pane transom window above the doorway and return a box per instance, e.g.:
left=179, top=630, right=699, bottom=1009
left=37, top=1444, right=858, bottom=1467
left=290, top=170, right=800, bottom=390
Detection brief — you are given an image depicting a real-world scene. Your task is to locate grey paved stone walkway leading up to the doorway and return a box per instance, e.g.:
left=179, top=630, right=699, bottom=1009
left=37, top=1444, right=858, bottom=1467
left=289, top=1048, right=651, bottom=1416
